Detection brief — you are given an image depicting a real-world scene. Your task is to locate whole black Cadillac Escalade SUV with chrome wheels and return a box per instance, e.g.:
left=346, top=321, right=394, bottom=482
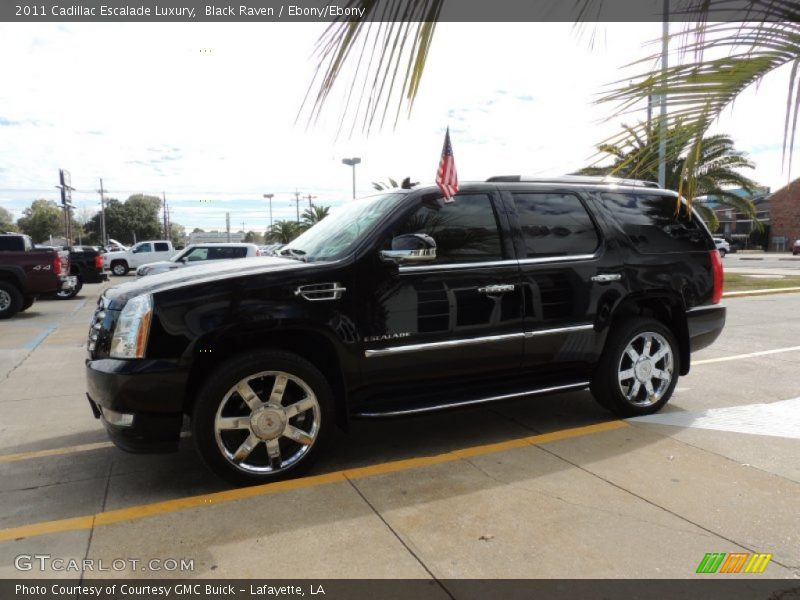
left=86, top=176, right=725, bottom=483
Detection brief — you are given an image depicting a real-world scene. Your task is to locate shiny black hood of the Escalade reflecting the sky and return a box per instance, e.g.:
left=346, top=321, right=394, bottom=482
left=104, top=256, right=318, bottom=310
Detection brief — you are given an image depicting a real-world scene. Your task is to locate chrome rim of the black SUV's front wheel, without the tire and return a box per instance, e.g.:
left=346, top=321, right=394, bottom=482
left=214, top=371, right=322, bottom=474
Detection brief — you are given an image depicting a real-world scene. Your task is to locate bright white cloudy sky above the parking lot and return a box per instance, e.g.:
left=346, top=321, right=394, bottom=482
left=0, top=23, right=800, bottom=231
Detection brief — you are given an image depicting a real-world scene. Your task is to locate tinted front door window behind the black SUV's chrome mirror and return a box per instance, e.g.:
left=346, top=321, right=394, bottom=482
left=387, top=194, right=503, bottom=263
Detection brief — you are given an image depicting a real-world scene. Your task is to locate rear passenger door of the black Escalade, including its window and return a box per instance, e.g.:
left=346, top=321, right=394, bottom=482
left=504, top=189, right=622, bottom=380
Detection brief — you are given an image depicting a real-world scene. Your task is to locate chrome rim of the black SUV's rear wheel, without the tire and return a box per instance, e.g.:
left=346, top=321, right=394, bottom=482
left=617, top=331, right=675, bottom=407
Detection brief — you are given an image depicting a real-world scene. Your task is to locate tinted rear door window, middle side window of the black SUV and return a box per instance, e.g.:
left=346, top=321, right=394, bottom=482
left=512, top=193, right=599, bottom=258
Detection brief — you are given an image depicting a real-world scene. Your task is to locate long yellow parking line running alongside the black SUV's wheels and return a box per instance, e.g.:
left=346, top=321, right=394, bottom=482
left=0, top=421, right=628, bottom=541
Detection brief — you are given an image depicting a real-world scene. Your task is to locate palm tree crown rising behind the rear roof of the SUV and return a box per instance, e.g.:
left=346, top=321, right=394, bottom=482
left=576, top=121, right=761, bottom=231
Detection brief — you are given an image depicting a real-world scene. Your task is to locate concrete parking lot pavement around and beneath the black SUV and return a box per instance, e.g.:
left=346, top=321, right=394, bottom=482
left=0, top=282, right=800, bottom=579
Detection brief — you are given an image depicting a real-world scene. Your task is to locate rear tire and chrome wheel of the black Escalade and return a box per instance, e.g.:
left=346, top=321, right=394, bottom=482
left=591, top=317, right=680, bottom=417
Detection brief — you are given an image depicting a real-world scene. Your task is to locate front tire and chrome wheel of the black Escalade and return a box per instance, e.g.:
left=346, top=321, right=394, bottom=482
left=192, top=351, right=333, bottom=485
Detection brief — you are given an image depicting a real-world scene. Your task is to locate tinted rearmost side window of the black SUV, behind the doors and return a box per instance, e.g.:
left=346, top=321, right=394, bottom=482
left=601, top=192, right=710, bottom=253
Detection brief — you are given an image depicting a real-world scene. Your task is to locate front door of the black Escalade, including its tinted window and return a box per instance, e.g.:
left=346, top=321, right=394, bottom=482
left=360, top=192, right=523, bottom=404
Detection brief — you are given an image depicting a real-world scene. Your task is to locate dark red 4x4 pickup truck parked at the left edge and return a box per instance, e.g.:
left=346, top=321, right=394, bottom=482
left=0, top=234, right=78, bottom=319
